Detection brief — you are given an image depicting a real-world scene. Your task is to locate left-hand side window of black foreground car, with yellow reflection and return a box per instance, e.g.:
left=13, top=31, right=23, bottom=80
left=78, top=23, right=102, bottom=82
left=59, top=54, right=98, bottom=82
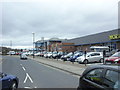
left=85, top=69, right=103, bottom=84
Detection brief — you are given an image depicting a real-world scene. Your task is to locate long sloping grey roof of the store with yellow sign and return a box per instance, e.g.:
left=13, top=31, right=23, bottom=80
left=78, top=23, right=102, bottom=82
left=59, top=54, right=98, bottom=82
left=65, top=29, right=120, bottom=45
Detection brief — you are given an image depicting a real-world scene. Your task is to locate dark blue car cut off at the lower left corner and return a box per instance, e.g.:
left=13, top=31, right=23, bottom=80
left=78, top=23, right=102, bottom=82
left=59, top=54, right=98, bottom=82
left=0, top=72, right=19, bottom=90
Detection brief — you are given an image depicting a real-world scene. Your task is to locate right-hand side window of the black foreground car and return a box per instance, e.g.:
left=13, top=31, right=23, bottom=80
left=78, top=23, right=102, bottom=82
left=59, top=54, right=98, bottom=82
left=103, top=70, right=120, bottom=88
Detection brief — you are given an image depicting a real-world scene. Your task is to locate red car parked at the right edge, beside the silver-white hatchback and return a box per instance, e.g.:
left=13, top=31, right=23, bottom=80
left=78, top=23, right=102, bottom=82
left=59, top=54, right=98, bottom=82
left=105, top=52, right=120, bottom=64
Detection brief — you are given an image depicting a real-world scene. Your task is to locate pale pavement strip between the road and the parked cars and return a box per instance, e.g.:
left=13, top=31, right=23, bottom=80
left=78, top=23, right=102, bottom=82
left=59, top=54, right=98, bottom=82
left=29, top=56, right=90, bottom=76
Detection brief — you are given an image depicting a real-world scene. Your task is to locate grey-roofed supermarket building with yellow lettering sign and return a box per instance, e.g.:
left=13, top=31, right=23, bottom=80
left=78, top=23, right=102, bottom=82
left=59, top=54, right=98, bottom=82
left=66, top=29, right=120, bottom=51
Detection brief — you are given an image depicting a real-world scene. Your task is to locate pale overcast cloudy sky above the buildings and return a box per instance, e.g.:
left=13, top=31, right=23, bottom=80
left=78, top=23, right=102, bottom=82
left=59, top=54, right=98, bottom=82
left=0, top=0, right=119, bottom=48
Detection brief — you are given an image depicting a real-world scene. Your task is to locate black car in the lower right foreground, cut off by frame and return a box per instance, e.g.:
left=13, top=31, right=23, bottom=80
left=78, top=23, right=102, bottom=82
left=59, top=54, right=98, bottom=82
left=78, top=64, right=120, bottom=90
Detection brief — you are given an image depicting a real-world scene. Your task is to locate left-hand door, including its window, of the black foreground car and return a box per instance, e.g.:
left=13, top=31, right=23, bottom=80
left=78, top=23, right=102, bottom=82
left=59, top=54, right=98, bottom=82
left=80, top=68, right=105, bottom=90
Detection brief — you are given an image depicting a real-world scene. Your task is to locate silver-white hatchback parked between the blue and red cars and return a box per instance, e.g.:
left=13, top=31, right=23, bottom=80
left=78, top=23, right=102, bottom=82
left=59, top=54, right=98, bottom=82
left=75, top=52, right=103, bottom=63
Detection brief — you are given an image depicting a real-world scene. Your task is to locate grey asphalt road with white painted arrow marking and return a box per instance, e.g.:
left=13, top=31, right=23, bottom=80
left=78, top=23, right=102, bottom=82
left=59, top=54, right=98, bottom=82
left=0, top=56, right=79, bottom=88
